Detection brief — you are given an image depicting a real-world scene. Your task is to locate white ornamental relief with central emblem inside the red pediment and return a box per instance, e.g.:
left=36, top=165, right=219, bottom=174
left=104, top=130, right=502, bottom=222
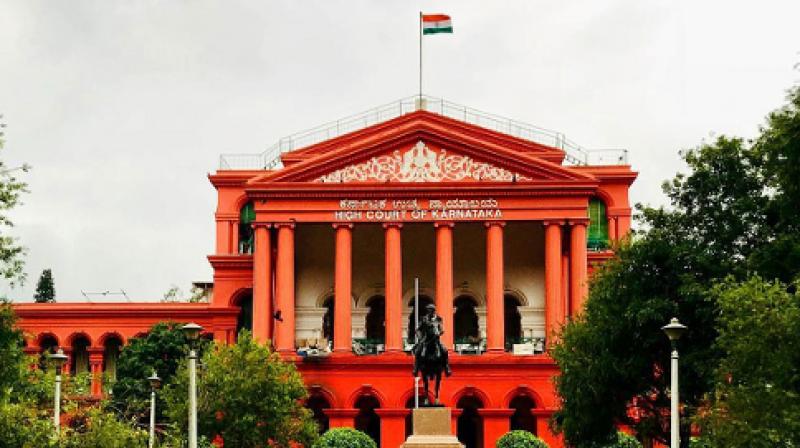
left=314, top=141, right=530, bottom=183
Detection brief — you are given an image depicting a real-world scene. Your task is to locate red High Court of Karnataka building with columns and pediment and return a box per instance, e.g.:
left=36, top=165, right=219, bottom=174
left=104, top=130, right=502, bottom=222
left=16, top=97, right=636, bottom=448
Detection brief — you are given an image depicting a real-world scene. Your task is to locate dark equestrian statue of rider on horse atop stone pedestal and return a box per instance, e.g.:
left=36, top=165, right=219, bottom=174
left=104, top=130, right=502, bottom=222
left=412, top=304, right=452, bottom=405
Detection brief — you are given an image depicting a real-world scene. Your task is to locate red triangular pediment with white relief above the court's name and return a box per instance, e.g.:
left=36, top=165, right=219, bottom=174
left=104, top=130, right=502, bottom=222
left=249, top=113, right=594, bottom=185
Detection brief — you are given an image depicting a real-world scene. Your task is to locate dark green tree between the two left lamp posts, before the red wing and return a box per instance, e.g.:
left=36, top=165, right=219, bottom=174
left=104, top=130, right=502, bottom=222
left=112, top=322, right=198, bottom=421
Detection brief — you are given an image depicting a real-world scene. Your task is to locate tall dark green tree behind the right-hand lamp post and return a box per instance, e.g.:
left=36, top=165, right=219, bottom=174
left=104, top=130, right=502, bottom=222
left=553, top=84, right=800, bottom=447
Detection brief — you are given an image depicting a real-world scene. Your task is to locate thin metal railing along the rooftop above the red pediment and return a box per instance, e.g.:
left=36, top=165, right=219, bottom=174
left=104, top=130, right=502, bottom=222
left=219, top=95, right=628, bottom=170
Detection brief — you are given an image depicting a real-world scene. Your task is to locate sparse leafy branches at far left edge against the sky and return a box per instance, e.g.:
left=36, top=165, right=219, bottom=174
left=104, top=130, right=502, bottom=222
left=0, top=115, right=30, bottom=286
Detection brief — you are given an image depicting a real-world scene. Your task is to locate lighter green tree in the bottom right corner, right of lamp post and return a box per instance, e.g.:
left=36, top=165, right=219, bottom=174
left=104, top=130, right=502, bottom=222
left=699, top=277, right=800, bottom=448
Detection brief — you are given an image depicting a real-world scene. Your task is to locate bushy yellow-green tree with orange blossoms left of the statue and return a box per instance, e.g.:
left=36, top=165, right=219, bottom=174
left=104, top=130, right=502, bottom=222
left=162, top=331, right=317, bottom=448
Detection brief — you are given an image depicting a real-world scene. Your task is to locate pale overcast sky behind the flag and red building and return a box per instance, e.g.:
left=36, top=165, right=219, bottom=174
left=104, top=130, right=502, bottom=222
left=0, top=0, right=800, bottom=301
